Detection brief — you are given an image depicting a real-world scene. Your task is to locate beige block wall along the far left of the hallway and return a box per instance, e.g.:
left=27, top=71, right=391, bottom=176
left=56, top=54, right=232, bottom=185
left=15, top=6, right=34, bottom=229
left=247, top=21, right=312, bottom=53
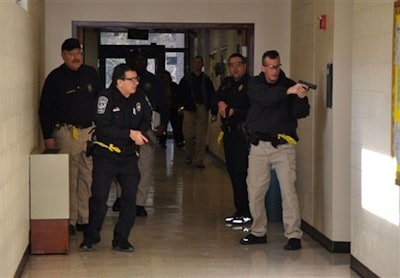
left=0, top=1, right=43, bottom=277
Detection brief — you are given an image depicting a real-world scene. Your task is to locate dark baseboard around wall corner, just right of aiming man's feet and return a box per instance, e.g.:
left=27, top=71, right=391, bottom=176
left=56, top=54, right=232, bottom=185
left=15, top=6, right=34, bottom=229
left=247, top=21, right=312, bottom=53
left=301, top=220, right=350, bottom=253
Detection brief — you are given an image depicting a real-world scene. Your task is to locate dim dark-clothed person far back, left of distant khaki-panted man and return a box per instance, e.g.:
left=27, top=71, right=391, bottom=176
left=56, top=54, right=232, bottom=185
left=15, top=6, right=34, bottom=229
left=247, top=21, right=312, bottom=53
left=160, top=70, right=185, bottom=147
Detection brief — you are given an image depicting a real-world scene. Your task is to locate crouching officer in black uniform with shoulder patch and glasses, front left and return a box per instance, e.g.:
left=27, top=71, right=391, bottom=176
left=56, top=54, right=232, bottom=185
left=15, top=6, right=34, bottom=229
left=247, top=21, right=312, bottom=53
left=80, top=64, right=151, bottom=252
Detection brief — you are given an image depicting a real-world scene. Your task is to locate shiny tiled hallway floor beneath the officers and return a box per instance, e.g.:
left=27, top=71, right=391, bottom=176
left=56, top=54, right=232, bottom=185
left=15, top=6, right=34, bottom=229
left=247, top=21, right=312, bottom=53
left=22, top=142, right=359, bottom=278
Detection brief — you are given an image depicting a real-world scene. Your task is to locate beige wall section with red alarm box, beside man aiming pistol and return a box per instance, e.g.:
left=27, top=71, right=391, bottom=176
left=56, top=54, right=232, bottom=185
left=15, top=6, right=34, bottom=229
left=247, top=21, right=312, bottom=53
left=291, top=1, right=352, bottom=242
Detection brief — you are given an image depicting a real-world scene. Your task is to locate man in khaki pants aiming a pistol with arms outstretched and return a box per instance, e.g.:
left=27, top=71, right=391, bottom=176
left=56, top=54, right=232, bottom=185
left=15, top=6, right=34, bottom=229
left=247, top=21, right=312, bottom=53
left=240, top=50, right=310, bottom=250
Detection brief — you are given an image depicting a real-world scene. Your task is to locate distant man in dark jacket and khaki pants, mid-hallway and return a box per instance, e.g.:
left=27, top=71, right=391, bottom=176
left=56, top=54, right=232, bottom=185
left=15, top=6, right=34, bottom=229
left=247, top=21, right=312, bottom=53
left=177, top=56, right=216, bottom=169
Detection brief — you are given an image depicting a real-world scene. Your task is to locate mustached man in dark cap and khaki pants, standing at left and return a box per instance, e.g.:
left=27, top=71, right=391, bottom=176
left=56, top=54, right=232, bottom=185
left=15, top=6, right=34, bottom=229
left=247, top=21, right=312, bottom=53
left=39, top=38, right=102, bottom=235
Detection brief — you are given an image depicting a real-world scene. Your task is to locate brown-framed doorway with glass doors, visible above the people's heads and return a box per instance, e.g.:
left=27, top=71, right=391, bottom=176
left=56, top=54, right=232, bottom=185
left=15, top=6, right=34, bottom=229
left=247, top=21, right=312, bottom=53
left=72, top=21, right=254, bottom=87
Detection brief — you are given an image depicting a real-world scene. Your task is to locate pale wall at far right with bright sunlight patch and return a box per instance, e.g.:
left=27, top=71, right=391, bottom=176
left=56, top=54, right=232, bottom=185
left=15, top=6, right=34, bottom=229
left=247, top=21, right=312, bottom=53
left=351, top=1, right=400, bottom=277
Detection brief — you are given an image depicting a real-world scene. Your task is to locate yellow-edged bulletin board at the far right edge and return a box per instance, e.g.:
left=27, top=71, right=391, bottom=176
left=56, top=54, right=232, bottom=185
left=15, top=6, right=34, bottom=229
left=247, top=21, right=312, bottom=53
left=392, top=1, right=400, bottom=185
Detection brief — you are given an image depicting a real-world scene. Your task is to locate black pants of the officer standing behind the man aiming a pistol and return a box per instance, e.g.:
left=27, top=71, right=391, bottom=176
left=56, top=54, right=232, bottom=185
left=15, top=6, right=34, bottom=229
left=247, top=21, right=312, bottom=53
left=223, top=129, right=251, bottom=216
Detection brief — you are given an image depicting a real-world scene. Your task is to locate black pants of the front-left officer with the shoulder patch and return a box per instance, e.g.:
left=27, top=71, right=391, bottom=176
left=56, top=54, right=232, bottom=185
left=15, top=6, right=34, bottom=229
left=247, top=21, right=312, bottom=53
left=85, top=154, right=140, bottom=242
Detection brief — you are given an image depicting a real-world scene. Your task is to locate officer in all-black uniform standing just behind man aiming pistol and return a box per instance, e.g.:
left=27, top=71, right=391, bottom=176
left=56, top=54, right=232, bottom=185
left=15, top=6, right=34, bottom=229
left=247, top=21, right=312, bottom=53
left=214, top=53, right=251, bottom=224
